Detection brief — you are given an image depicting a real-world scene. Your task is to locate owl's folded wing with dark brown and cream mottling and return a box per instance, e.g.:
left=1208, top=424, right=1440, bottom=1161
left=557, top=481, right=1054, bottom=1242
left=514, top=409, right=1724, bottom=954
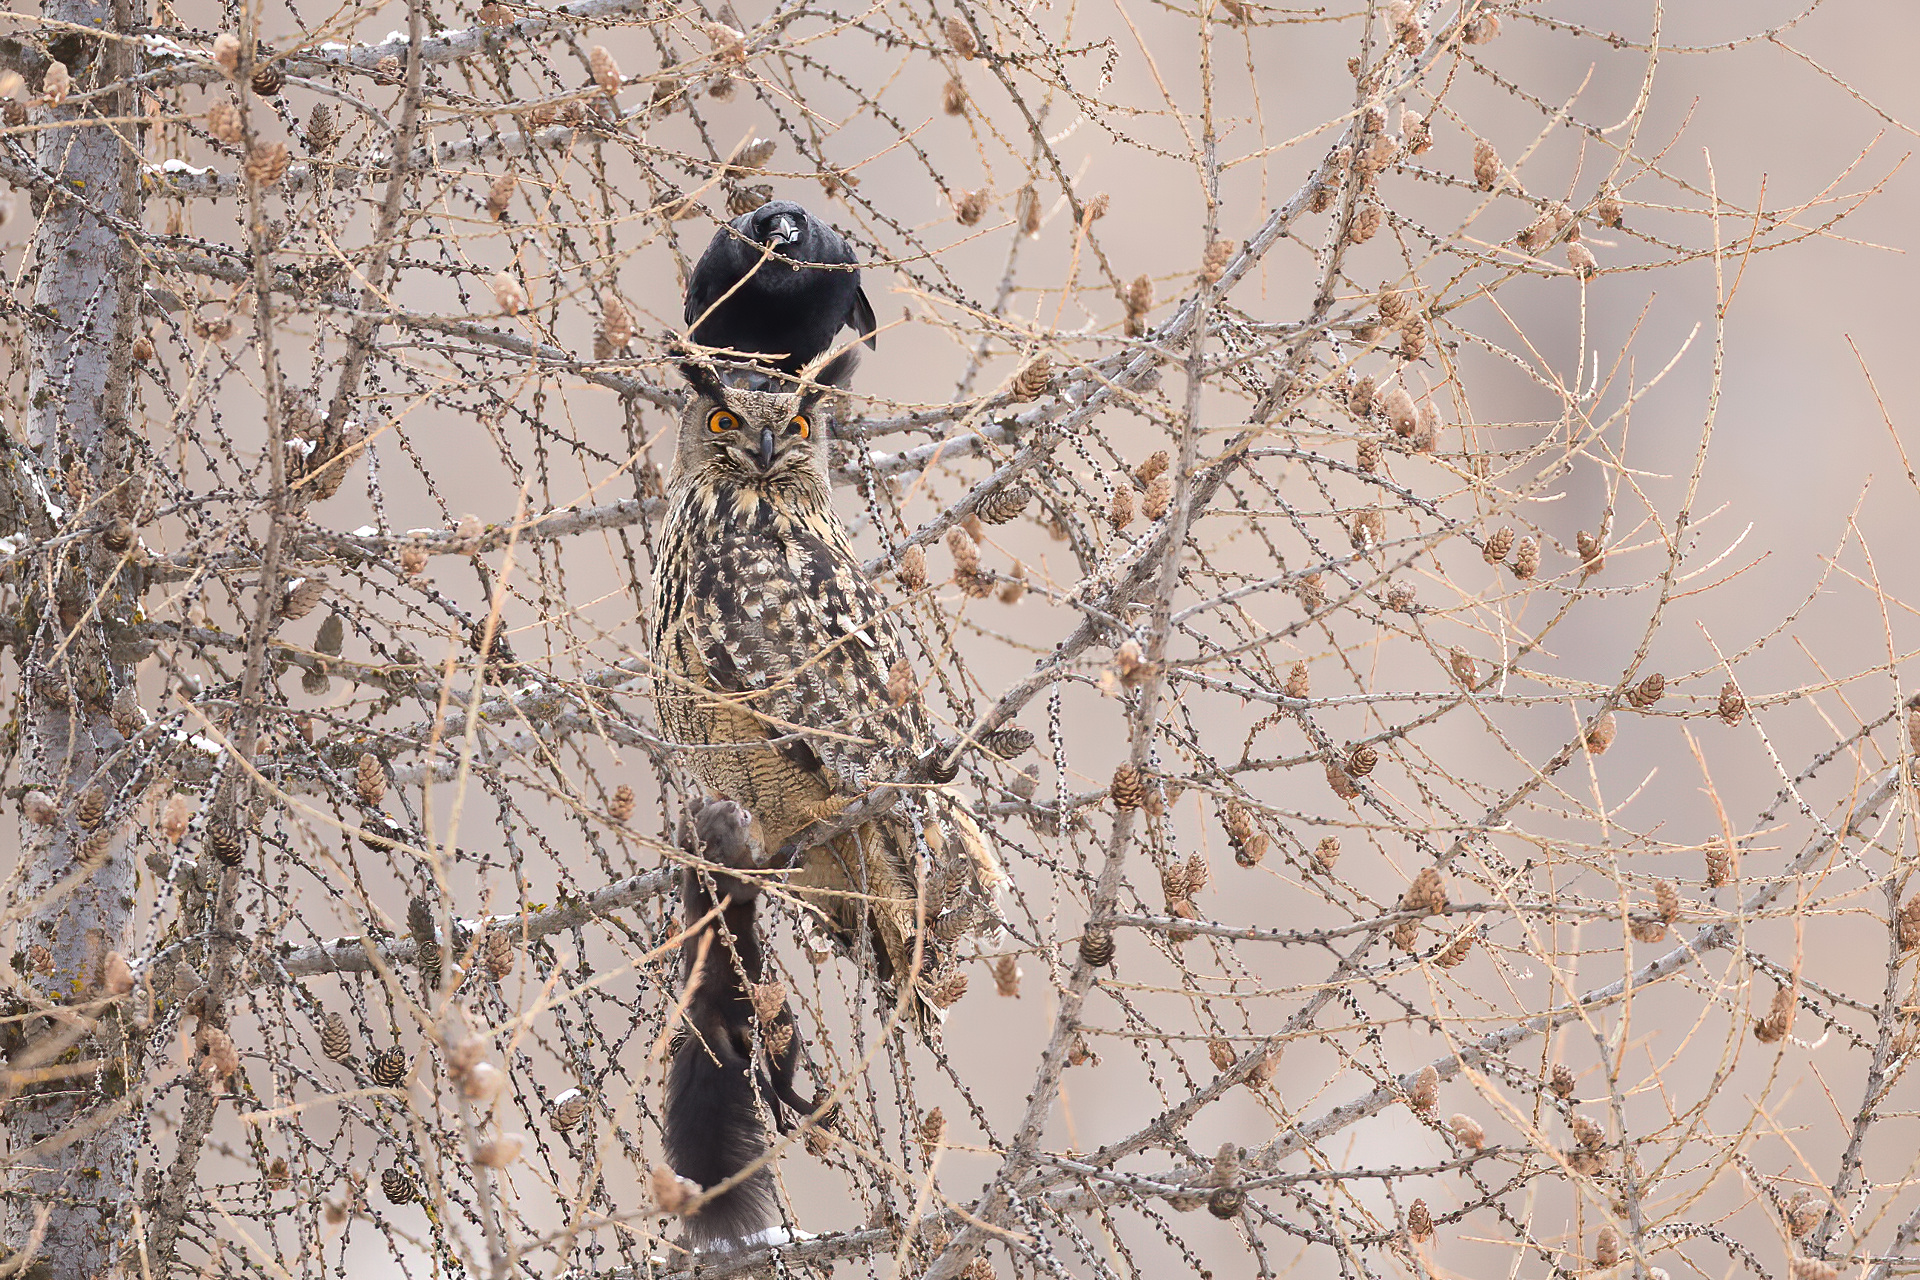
left=687, top=533, right=931, bottom=794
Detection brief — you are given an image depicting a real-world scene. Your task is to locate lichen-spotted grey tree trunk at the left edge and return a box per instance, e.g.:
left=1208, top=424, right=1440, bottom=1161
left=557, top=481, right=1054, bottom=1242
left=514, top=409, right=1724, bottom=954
left=0, top=0, right=142, bottom=1276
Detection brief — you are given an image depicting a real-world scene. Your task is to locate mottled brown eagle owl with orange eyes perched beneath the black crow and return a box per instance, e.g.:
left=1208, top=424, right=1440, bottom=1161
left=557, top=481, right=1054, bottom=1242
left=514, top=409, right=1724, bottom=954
left=651, top=351, right=1004, bottom=1034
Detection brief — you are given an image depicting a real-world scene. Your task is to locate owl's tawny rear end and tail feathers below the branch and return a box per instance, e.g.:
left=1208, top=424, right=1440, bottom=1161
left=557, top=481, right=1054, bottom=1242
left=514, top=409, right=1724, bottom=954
left=791, top=791, right=1006, bottom=1040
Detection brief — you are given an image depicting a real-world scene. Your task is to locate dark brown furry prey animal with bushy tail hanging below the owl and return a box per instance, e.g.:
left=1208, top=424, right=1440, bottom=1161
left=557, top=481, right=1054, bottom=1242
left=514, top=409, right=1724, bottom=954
left=662, top=800, right=826, bottom=1249
